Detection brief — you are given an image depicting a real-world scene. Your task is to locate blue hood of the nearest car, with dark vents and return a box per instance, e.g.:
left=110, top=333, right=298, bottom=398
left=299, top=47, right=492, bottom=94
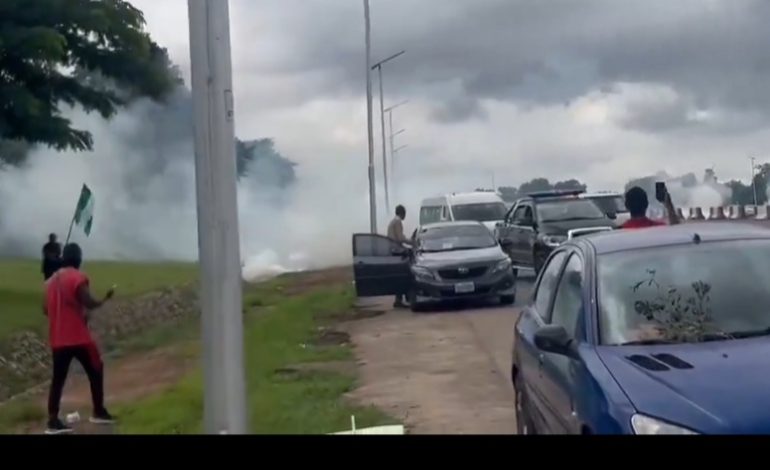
left=597, top=337, right=770, bottom=434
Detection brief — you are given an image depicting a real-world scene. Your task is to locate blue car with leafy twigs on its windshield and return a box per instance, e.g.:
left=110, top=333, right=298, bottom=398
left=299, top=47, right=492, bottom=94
left=512, top=223, right=770, bottom=434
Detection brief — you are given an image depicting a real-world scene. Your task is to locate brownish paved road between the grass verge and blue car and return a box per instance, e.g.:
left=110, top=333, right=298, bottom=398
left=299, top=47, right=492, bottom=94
left=348, top=278, right=531, bottom=434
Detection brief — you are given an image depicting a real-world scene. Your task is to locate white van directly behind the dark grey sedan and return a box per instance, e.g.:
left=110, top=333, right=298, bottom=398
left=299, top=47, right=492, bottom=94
left=420, top=191, right=508, bottom=230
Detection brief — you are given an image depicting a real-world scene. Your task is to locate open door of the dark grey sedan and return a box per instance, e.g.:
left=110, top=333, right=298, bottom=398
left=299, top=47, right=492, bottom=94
left=353, top=233, right=412, bottom=297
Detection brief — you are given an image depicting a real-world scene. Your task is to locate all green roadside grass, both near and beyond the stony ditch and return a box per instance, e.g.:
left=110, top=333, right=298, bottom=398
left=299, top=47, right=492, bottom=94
left=0, top=261, right=394, bottom=434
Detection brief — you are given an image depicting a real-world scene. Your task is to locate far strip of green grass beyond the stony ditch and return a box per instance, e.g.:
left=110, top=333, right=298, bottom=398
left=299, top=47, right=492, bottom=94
left=0, top=260, right=197, bottom=342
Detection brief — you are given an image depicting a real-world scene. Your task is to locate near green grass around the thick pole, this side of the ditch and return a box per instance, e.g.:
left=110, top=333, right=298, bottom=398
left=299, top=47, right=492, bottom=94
left=116, top=281, right=394, bottom=434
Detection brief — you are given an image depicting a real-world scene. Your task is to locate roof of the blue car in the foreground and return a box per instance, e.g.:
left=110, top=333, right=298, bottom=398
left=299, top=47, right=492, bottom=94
left=583, top=221, right=770, bottom=255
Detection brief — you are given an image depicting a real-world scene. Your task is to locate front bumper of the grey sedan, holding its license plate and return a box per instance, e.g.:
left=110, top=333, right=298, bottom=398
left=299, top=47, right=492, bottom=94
left=413, top=271, right=516, bottom=303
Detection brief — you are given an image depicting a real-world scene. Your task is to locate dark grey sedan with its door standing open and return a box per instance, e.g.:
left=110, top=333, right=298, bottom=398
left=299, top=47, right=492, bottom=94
left=353, top=221, right=516, bottom=311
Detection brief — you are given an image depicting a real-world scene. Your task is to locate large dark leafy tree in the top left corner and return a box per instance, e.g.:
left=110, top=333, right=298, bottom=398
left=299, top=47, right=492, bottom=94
left=0, top=0, right=179, bottom=151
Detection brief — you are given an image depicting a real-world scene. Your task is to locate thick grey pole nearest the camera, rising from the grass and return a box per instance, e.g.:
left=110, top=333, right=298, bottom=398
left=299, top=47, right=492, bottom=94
left=188, top=0, right=247, bottom=434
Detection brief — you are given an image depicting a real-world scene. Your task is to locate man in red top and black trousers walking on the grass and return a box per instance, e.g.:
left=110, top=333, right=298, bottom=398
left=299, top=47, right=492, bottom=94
left=43, top=243, right=115, bottom=434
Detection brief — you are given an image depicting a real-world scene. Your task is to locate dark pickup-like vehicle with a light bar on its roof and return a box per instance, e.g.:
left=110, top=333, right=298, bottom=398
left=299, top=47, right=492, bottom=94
left=495, top=191, right=616, bottom=274
